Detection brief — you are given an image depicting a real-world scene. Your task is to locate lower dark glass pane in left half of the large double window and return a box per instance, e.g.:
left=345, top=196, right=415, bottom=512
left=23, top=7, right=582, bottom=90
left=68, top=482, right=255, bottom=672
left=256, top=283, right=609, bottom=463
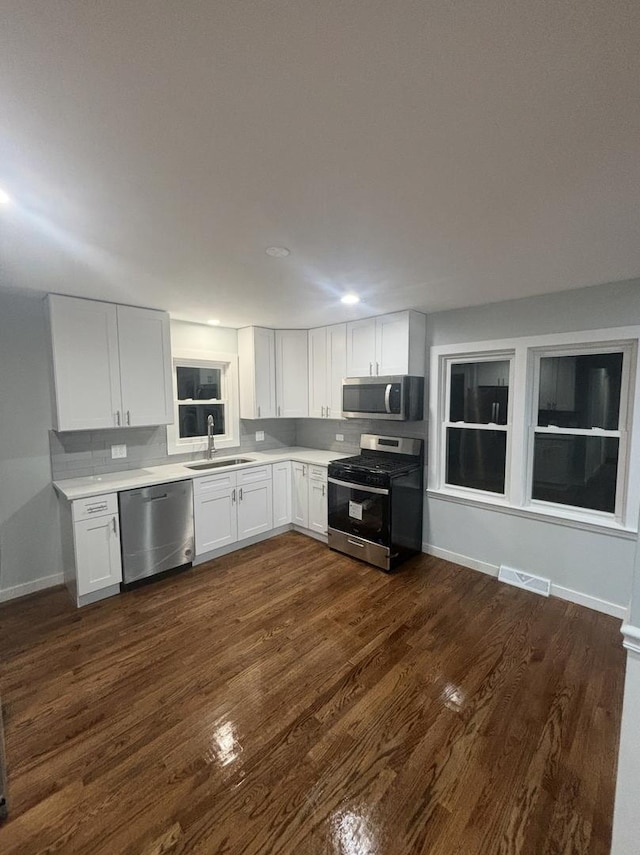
left=447, top=428, right=507, bottom=493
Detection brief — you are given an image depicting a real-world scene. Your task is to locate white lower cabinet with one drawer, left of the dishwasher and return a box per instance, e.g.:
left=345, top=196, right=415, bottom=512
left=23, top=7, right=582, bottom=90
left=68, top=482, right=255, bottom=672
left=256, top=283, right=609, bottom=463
left=65, top=493, right=122, bottom=605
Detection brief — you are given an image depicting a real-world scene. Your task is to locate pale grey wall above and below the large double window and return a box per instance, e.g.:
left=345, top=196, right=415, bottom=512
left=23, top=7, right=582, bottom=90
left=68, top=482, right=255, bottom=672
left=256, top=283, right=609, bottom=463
left=423, top=280, right=640, bottom=615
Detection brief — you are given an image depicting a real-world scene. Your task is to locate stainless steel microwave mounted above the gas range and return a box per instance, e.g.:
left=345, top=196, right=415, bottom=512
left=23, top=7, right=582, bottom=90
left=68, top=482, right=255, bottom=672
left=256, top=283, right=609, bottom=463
left=342, top=375, right=424, bottom=421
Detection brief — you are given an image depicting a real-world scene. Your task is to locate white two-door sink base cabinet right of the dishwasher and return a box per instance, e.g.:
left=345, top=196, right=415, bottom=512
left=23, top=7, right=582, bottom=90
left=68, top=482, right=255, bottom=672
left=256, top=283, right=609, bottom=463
left=193, top=466, right=273, bottom=556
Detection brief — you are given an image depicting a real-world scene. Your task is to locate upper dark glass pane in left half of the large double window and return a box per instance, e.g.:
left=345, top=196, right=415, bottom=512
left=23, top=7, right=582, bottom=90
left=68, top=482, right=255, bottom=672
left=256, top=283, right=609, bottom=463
left=449, top=359, right=509, bottom=425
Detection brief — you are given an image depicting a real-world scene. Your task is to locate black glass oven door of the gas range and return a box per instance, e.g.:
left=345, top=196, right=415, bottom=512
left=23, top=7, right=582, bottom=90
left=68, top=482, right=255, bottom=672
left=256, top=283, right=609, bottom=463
left=328, top=478, right=390, bottom=546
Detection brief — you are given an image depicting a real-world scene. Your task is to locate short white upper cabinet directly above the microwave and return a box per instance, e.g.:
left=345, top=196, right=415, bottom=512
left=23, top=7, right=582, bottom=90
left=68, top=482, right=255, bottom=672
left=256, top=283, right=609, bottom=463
left=346, top=311, right=426, bottom=377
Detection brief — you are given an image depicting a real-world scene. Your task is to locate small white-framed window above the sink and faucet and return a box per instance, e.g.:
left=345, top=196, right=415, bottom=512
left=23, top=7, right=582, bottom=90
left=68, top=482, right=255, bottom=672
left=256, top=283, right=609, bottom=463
left=167, top=353, right=239, bottom=454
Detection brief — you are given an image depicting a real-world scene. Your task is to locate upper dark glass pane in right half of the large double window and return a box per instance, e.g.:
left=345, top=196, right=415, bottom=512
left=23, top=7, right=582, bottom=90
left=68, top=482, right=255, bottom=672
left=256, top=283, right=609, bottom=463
left=538, top=353, right=622, bottom=430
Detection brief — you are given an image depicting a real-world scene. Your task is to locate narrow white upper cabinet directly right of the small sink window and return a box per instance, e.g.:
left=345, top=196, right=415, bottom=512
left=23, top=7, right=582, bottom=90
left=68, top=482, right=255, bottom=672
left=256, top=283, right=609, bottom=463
left=238, top=327, right=277, bottom=419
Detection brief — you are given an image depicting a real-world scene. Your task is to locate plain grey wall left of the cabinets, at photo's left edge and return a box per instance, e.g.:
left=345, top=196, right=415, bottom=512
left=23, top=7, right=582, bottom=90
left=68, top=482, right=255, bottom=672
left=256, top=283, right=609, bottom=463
left=0, top=291, right=62, bottom=599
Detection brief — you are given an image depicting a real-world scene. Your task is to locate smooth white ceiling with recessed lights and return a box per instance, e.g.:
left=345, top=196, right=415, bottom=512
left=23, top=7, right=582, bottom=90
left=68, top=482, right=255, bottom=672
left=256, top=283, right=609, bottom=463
left=0, top=0, right=640, bottom=327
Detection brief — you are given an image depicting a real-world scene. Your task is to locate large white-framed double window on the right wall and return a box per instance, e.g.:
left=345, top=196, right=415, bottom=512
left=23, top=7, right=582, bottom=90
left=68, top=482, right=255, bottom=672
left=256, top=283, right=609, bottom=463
left=429, top=327, right=640, bottom=528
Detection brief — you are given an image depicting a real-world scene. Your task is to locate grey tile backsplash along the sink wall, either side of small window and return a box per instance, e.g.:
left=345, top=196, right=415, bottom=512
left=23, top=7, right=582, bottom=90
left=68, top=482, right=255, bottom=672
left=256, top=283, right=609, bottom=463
left=49, top=419, right=296, bottom=481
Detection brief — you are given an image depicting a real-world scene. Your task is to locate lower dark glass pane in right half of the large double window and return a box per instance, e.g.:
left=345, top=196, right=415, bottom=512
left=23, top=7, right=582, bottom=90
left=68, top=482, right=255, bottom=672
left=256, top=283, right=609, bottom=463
left=532, top=434, right=619, bottom=514
